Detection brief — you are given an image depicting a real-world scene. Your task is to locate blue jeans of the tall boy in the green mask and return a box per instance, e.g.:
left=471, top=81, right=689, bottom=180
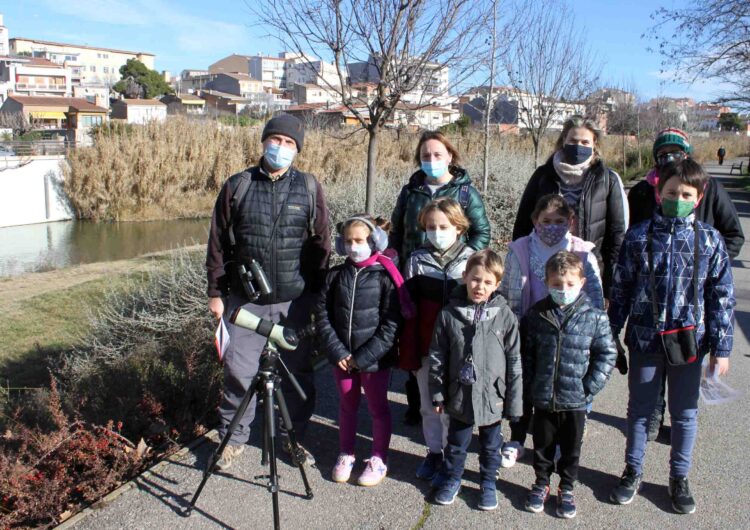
left=625, top=351, right=701, bottom=477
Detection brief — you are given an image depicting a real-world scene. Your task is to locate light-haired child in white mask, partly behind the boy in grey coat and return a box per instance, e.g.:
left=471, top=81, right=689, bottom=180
left=399, top=197, right=474, bottom=480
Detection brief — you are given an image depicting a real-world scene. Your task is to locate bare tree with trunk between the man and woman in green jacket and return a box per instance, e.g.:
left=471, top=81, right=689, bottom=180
left=252, top=0, right=485, bottom=213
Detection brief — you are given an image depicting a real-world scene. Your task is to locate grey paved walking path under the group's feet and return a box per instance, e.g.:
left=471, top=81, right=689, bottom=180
left=67, top=159, right=750, bottom=530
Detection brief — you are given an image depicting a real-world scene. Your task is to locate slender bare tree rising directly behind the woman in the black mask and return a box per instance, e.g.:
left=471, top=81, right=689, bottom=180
left=505, top=0, right=600, bottom=164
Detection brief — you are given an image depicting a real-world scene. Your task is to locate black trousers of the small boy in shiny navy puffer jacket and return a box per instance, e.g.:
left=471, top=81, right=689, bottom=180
left=533, top=409, right=586, bottom=491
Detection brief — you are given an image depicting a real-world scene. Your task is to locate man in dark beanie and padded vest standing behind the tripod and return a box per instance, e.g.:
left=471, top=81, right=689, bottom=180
left=206, top=114, right=331, bottom=470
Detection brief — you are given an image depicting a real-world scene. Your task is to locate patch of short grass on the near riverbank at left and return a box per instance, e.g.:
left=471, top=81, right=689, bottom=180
left=0, top=273, right=141, bottom=388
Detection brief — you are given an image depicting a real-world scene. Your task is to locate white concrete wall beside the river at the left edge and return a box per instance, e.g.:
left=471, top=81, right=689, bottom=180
left=0, top=156, right=73, bottom=227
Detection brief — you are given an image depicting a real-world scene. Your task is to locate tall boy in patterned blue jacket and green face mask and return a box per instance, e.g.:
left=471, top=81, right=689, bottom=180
left=609, top=159, right=735, bottom=513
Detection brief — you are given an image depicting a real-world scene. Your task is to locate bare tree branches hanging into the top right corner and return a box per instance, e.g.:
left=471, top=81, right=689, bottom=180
left=648, top=0, right=750, bottom=109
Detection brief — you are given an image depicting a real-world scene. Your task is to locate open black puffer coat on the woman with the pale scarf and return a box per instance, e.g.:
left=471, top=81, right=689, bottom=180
left=513, top=157, right=626, bottom=298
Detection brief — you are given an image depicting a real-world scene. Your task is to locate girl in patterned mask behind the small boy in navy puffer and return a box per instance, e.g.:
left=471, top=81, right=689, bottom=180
left=500, top=194, right=604, bottom=467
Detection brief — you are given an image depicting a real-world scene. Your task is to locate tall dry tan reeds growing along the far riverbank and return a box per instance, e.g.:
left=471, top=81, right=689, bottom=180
left=64, top=117, right=747, bottom=225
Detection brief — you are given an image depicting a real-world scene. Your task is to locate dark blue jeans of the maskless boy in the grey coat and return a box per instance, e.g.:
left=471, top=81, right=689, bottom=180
left=437, top=418, right=503, bottom=487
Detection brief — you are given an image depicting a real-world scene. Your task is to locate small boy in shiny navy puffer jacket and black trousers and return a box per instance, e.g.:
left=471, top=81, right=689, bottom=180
left=521, top=250, right=617, bottom=519
